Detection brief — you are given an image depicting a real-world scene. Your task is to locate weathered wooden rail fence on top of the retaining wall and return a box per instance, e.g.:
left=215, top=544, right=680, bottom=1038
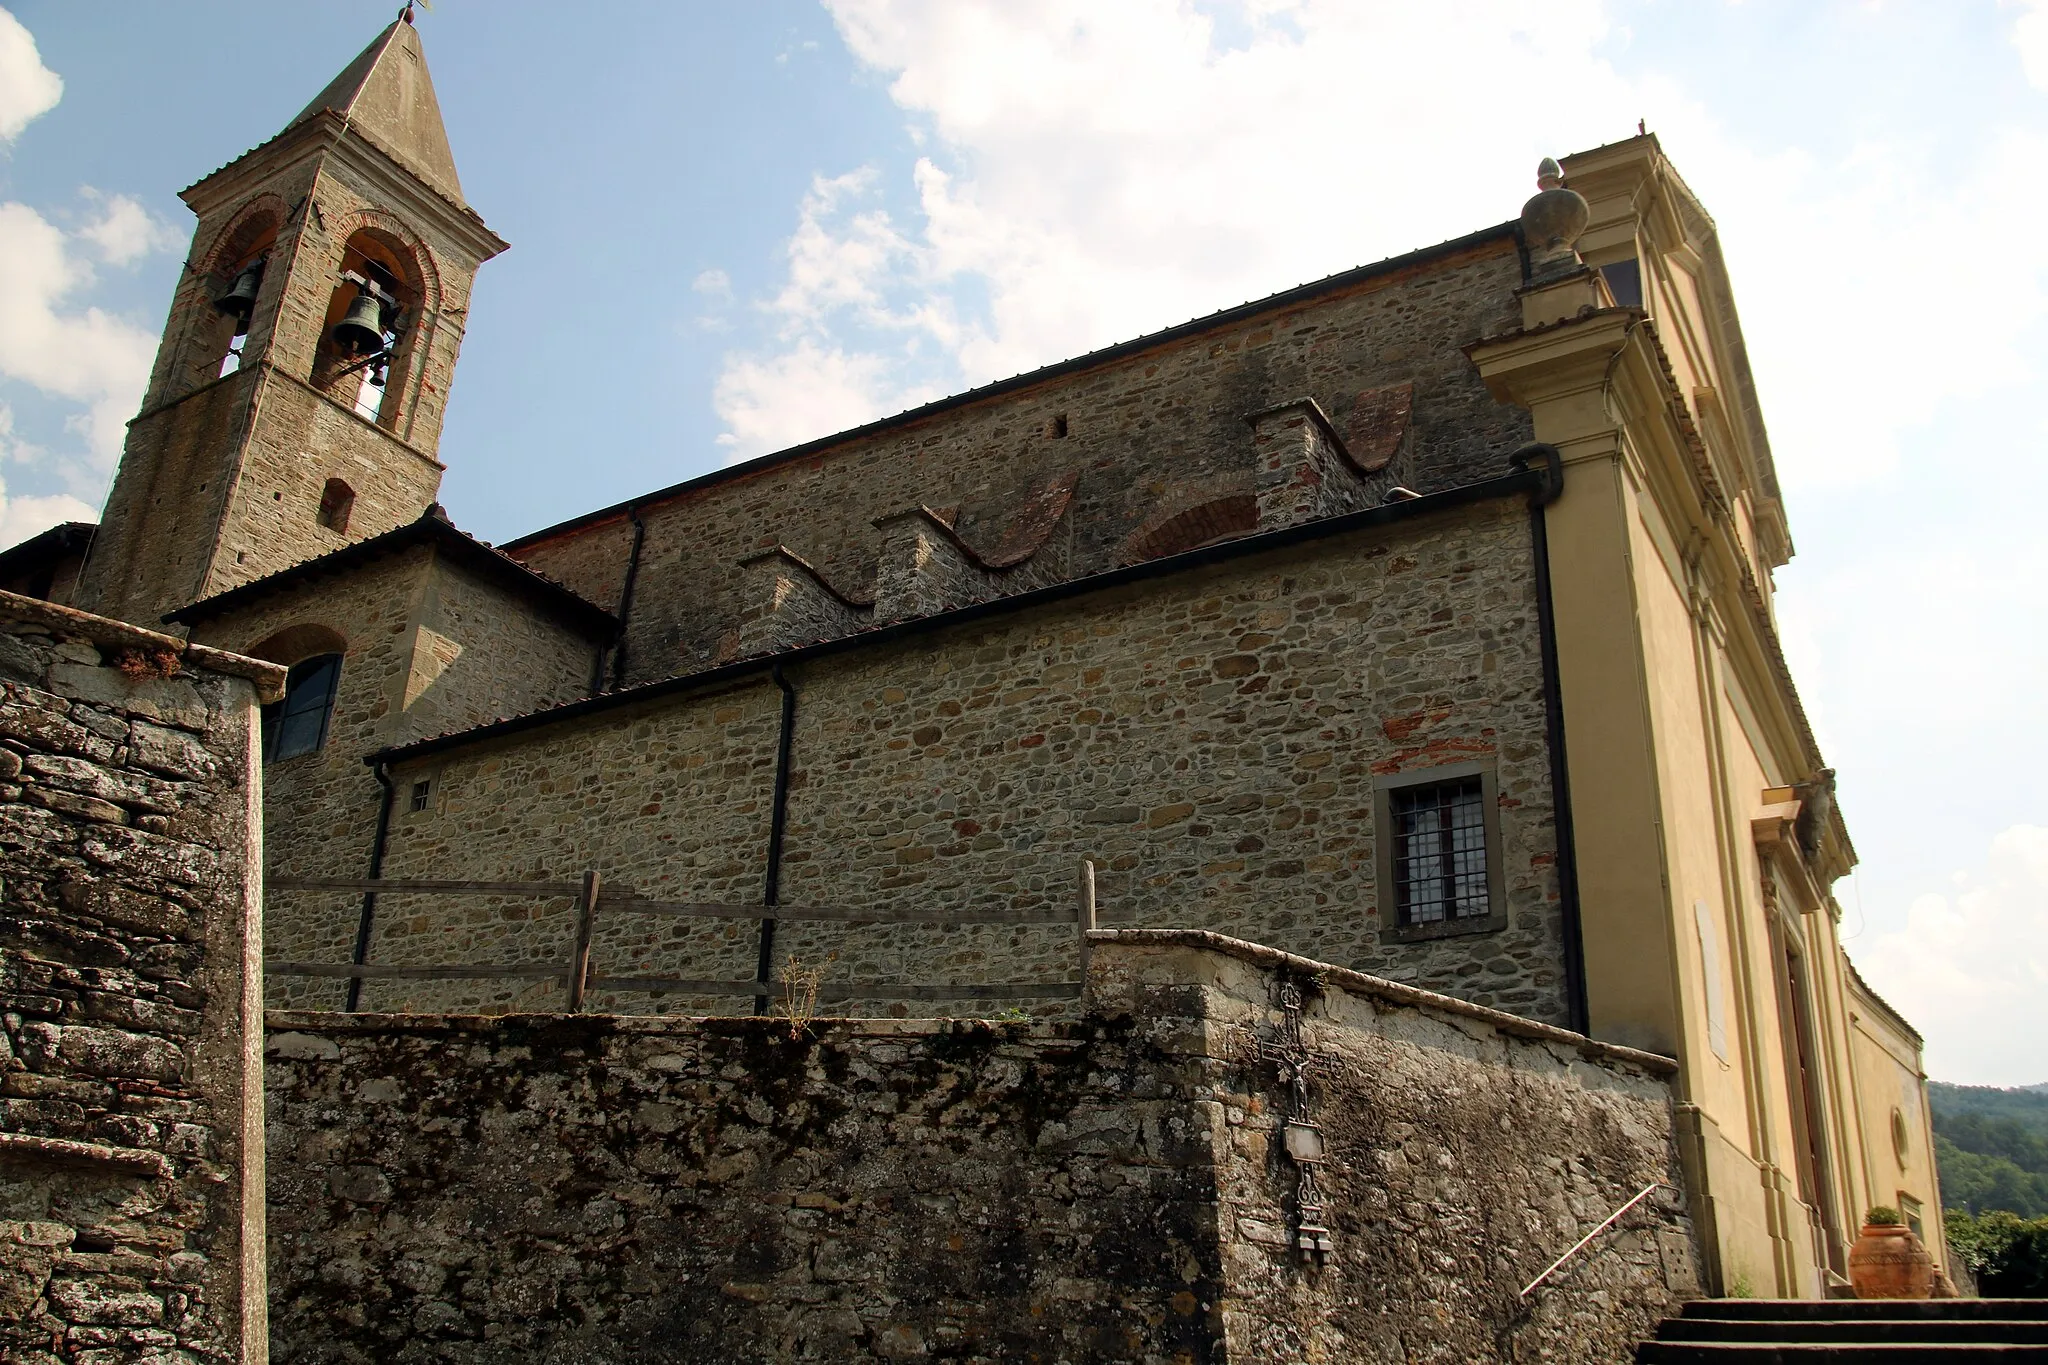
left=264, top=857, right=1096, bottom=1013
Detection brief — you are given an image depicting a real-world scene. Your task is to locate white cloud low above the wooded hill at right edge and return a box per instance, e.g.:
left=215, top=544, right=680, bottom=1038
left=1855, top=825, right=2048, bottom=1085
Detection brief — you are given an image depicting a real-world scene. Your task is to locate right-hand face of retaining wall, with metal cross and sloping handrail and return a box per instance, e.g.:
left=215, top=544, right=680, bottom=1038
left=1092, top=931, right=1700, bottom=1365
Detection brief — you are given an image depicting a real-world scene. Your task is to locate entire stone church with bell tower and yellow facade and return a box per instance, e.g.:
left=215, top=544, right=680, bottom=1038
left=0, top=14, right=1944, bottom=1334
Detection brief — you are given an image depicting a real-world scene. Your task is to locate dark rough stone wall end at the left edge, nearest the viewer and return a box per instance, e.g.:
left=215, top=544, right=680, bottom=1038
left=0, top=593, right=283, bottom=1365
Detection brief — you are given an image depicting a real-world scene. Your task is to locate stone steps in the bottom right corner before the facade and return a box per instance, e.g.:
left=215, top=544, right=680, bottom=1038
left=1636, top=1300, right=2048, bottom=1365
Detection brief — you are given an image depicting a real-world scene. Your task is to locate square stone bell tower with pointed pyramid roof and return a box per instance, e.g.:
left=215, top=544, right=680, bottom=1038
left=76, top=6, right=506, bottom=628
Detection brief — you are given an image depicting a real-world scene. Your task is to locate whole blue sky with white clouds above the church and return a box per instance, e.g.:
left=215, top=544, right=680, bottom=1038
left=0, top=0, right=2048, bottom=1085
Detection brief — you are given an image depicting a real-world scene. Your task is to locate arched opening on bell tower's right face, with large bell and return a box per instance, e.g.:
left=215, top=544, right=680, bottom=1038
left=313, top=227, right=426, bottom=428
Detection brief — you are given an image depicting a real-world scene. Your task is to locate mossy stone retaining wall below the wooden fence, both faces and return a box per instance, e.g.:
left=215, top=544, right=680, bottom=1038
left=268, top=933, right=1694, bottom=1365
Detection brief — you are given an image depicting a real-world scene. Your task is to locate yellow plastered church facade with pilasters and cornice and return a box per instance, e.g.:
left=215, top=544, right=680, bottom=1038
left=1470, top=137, right=1944, bottom=1297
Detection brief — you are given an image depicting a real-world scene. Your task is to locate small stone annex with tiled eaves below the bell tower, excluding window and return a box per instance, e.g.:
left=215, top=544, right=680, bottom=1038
left=181, top=546, right=594, bottom=1005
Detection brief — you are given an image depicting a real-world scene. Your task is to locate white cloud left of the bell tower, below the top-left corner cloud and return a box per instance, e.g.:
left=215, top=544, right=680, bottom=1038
left=0, top=203, right=156, bottom=469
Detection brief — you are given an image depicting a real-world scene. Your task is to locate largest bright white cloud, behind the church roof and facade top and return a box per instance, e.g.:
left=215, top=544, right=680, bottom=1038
left=704, top=0, right=2048, bottom=489
